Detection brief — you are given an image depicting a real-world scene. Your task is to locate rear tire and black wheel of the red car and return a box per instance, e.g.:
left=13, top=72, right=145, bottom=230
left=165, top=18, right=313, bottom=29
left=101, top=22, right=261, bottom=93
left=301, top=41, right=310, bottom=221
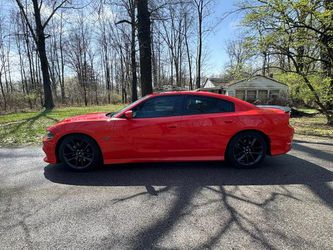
left=226, top=131, right=267, bottom=168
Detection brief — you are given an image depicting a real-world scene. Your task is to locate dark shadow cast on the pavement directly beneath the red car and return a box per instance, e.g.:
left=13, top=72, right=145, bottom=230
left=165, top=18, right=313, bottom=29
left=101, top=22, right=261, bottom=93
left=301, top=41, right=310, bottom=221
left=44, top=155, right=333, bottom=207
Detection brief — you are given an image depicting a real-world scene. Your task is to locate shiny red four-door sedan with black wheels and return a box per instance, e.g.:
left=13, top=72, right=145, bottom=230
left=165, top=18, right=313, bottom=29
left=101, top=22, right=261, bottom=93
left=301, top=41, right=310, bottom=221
left=43, top=91, right=294, bottom=170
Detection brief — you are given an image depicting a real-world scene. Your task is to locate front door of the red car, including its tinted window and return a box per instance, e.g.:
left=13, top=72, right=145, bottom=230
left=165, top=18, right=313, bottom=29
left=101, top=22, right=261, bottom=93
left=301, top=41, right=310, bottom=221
left=114, top=95, right=184, bottom=161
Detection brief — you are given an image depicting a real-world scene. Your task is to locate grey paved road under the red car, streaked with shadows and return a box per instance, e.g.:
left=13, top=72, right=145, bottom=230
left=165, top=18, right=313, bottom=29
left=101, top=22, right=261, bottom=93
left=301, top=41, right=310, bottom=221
left=0, top=140, right=333, bottom=249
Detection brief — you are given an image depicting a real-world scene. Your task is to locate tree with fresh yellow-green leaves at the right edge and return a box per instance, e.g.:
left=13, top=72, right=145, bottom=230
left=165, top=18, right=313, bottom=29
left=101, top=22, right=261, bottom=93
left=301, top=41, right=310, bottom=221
left=243, top=0, right=333, bottom=124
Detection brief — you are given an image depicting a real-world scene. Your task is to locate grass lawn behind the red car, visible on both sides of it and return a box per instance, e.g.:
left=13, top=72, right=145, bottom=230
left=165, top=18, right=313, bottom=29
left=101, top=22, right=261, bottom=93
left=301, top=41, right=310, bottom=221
left=0, top=105, right=333, bottom=146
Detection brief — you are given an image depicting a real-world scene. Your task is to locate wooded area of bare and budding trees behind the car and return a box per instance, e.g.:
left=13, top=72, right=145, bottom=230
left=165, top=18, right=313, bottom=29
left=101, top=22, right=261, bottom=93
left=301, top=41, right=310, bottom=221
left=0, top=0, right=333, bottom=124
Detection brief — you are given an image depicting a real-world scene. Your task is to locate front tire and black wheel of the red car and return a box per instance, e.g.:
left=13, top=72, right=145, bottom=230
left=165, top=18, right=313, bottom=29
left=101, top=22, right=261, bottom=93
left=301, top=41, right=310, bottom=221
left=58, top=134, right=101, bottom=171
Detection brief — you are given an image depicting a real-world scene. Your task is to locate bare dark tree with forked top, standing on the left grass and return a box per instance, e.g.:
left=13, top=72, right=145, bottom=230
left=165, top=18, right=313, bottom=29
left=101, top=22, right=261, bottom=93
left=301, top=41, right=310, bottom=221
left=16, top=0, right=68, bottom=109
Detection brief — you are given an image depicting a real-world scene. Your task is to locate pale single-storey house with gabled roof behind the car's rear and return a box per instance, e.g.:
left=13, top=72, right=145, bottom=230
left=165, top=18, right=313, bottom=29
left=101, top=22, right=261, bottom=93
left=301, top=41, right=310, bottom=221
left=201, top=75, right=289, bottom=104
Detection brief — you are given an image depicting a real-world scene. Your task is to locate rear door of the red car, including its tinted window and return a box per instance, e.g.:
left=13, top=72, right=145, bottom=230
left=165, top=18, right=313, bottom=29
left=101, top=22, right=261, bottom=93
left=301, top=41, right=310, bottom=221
left=180, top=95, right=237, bottom=160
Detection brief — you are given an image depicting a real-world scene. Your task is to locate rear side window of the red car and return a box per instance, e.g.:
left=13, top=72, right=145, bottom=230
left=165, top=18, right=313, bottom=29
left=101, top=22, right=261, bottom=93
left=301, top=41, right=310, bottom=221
left=185, top=96, right=235, bottom=115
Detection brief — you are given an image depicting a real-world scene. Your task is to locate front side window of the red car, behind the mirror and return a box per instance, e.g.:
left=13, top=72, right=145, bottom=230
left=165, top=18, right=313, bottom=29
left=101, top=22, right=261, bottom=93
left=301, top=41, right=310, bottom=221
left=133, top=95, right=183, bottom=118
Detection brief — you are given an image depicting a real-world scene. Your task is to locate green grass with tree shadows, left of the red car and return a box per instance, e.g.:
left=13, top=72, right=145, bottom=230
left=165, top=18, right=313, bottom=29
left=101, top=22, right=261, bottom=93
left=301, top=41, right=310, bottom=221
left=0, top=105, right=124, bottom=146
